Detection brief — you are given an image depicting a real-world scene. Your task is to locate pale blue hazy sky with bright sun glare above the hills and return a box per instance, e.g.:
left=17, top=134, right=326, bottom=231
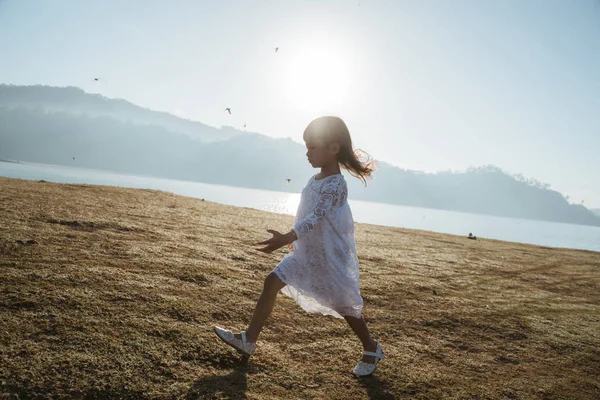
left=0, top=0, right=600, bottom=208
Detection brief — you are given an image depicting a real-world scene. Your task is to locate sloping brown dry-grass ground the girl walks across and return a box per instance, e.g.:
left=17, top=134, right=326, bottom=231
left=0, top=178, right=600, bottom=400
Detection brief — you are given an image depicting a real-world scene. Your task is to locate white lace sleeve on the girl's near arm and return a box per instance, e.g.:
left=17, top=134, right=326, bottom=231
left=293, top=178, right=348, bottom=239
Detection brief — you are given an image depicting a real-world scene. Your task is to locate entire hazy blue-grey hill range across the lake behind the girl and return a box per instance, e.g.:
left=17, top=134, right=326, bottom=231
left=0, top=86, right=600, bottom=226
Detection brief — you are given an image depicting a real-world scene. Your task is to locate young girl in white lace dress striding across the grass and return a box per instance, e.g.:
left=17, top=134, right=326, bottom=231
left=214, top=117, right=384, bottom=376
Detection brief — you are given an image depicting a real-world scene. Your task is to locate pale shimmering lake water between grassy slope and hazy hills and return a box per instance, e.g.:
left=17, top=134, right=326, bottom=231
left=0, top=162, right=600, bottom=251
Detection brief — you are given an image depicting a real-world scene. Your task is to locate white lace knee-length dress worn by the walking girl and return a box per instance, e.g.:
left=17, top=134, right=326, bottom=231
left=274, top=174, right=363, bottom=318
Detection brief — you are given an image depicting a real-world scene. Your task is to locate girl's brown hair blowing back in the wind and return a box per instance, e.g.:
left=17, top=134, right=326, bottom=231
left=303, top=116, right=377, bottom=186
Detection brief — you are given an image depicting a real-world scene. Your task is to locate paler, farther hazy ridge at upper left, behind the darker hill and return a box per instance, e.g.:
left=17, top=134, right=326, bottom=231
left=0, top=85, right=239, bottom=142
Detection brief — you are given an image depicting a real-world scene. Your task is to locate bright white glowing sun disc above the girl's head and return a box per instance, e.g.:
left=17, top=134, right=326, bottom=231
left=283, top=43, right=352, bottom=112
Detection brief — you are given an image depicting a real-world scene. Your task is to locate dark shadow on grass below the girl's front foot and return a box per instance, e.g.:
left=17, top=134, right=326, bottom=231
left=186, top=362, right=250, bottom=400
